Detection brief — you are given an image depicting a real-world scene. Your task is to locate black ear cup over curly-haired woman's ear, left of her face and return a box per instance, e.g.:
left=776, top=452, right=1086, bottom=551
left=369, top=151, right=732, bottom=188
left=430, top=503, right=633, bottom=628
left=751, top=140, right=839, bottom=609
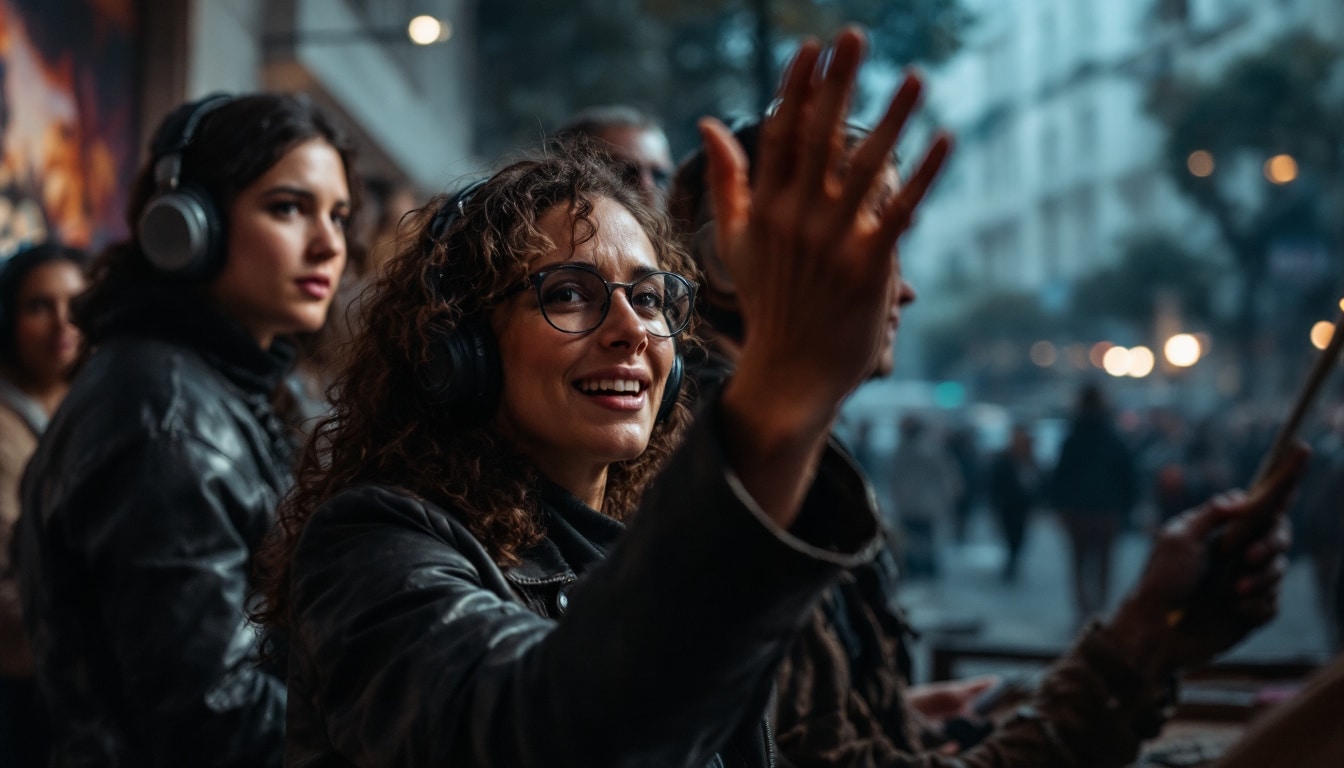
left=421, top=321, right=504, bottom=424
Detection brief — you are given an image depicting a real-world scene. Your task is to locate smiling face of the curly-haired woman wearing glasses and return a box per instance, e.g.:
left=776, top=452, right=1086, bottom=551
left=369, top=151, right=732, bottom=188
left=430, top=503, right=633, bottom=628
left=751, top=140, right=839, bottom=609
left=493, top=198, right=675, bottom=491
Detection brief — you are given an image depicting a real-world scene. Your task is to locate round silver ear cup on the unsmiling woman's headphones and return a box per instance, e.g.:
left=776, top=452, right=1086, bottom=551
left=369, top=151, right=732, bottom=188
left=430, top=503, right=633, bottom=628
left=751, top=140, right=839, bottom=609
left=140, top=184, right=224, bottom=280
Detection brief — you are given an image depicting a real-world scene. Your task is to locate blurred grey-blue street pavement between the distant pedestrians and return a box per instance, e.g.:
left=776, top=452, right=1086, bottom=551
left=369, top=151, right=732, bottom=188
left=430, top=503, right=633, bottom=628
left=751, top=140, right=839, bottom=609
left=900, top=510, right=1331, bottom=681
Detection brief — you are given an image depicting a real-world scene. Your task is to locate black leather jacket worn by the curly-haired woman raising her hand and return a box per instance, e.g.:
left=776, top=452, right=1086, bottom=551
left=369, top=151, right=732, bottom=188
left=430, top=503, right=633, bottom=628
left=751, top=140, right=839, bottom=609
left=286, top=406, right=879, bottom=768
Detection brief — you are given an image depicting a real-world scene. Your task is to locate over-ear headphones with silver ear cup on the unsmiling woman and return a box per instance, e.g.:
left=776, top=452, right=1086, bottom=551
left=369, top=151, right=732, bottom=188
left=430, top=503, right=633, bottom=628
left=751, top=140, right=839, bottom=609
left=140, top=93, right=234, bottom=280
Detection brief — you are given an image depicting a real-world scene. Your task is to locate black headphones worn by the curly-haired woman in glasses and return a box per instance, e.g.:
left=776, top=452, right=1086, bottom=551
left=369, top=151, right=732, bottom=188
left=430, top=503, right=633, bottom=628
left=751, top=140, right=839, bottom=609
left=419, top=179, right=685, bottom=424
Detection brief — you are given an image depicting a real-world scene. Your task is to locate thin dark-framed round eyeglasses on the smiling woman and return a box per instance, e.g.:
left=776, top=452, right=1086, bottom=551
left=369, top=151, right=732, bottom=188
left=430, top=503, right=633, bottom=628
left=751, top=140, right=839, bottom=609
left=504, top=264, right=695, bottom=338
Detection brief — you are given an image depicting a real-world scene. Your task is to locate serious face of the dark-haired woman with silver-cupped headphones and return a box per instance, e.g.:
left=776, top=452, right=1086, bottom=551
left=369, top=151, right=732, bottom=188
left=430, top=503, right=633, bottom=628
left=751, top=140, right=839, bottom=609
left=207, top=139, right=351, bottom=347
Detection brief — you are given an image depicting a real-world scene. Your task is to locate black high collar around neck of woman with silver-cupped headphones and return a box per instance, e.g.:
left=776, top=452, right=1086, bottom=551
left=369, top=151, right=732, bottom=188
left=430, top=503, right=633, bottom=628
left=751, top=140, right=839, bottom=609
left=101, top=285, right=297, bottom=395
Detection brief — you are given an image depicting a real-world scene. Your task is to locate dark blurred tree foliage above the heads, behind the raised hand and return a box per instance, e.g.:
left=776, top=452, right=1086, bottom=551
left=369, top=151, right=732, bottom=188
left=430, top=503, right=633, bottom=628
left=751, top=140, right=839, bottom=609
left=474, top=0, right=970, bottom=157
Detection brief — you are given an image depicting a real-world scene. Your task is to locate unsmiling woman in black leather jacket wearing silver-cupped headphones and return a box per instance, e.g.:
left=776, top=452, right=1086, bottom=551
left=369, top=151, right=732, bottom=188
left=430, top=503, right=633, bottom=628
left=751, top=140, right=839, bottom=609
left=15, top=94, right=356, bottom=767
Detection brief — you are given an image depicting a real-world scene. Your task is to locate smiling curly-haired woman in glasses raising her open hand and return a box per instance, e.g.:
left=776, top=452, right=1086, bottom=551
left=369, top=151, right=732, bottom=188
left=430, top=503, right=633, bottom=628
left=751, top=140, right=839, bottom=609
left=258, top=31, right=946, bottom=767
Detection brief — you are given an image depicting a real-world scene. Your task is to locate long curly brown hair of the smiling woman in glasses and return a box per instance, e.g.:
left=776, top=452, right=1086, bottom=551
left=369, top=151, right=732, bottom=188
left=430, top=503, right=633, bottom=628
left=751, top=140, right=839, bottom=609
left=253, top=144, right=696, bottom=637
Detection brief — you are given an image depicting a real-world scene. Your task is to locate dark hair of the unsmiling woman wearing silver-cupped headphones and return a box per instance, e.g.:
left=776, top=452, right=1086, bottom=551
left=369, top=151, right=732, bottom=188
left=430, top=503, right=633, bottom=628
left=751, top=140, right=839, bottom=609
left=73, top=93, right=359, bottom=346
